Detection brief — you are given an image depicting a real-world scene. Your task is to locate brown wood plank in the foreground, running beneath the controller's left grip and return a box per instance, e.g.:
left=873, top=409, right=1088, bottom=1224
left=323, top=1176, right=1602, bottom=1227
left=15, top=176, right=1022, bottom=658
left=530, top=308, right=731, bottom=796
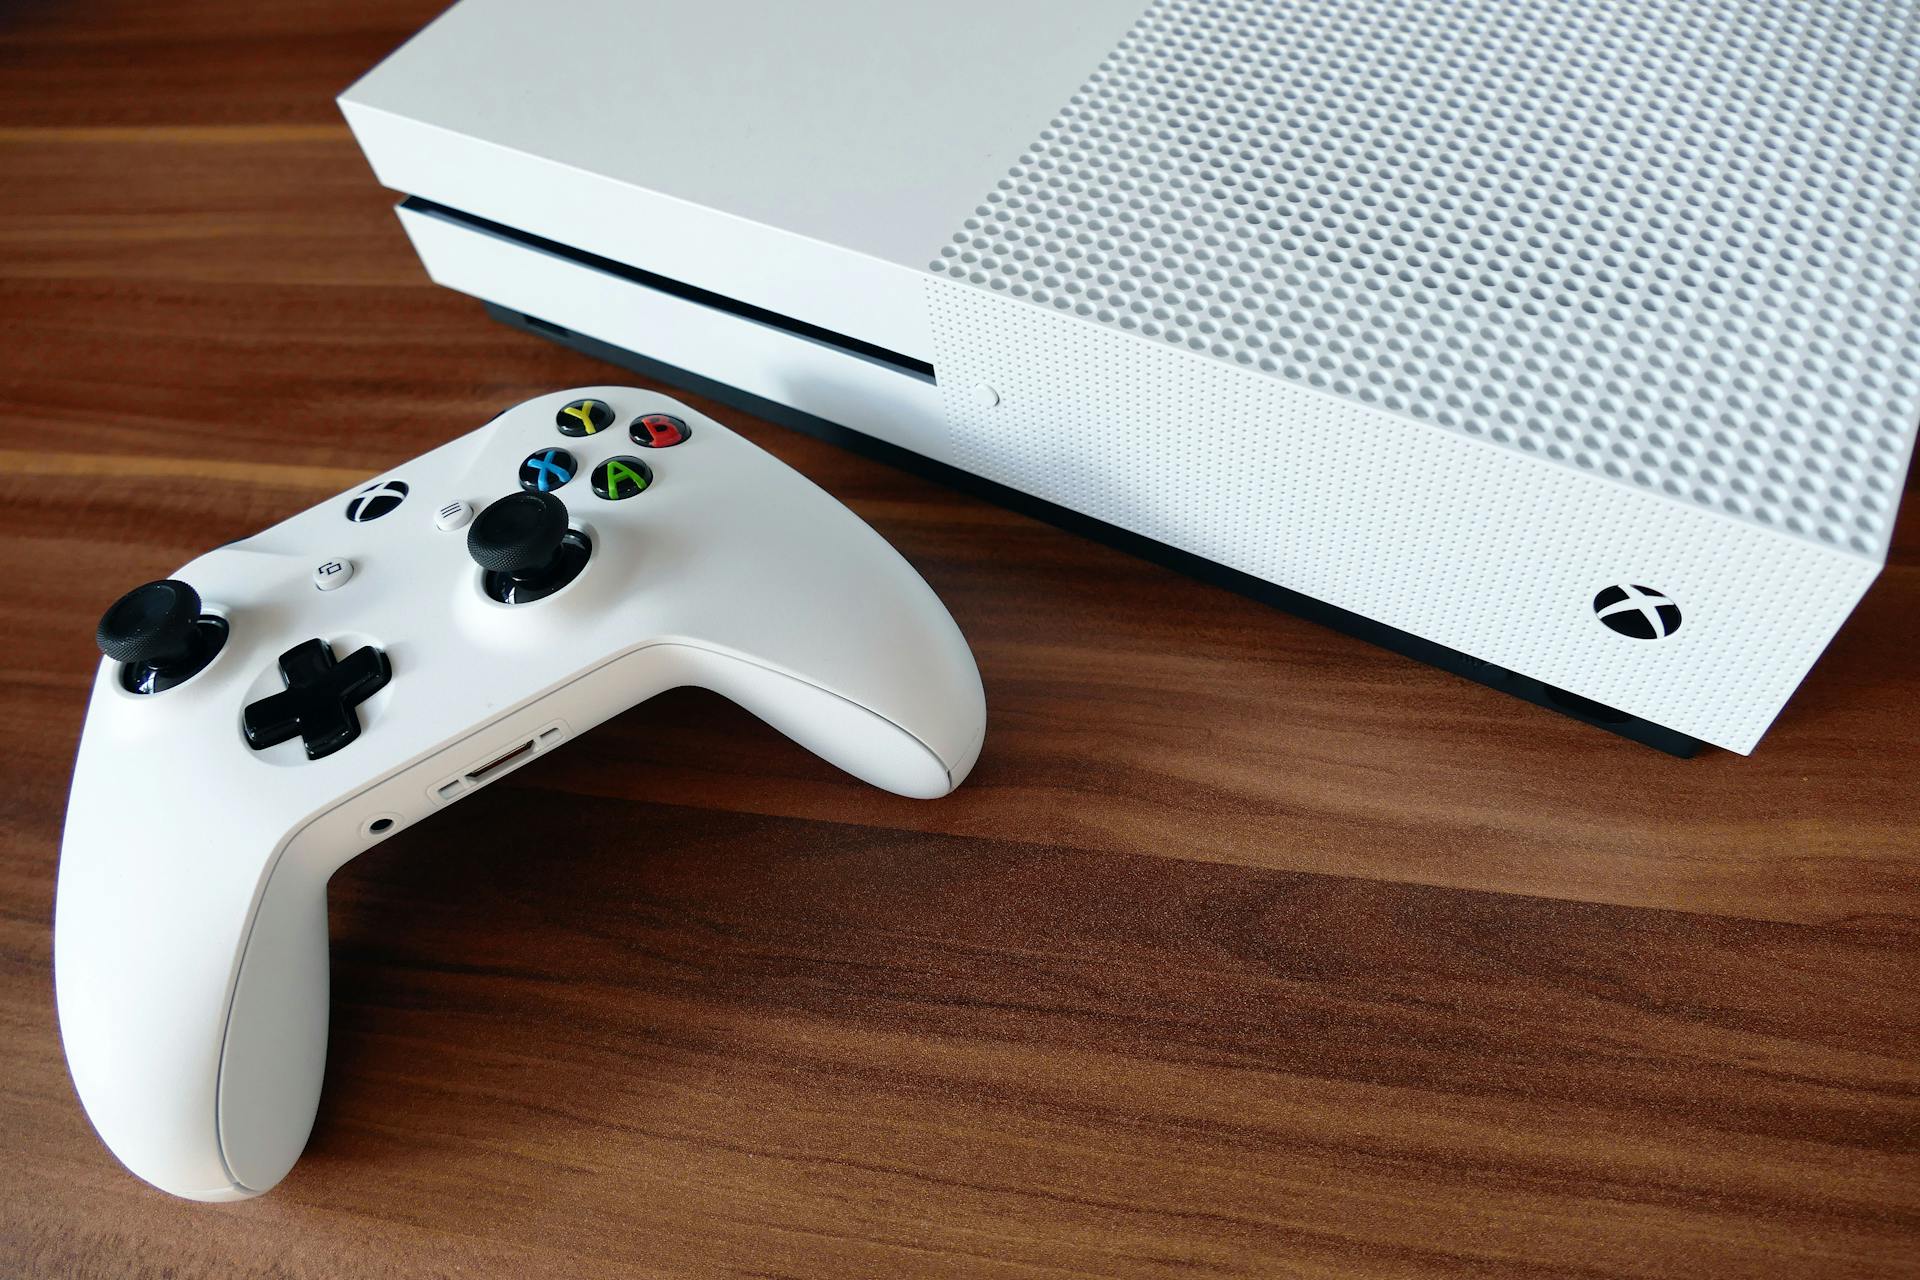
left=4, top=794, right=1920, bottom=1276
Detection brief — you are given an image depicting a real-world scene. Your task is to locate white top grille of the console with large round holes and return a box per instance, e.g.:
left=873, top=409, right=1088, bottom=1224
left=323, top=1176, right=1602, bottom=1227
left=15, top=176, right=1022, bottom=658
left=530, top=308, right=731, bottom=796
left=931, top=0, right=1920, bottom=557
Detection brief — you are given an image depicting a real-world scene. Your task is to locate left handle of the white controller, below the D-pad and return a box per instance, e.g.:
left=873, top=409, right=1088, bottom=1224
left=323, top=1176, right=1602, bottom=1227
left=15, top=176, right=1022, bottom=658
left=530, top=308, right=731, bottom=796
left=54, top=790, right=330, bottom=1201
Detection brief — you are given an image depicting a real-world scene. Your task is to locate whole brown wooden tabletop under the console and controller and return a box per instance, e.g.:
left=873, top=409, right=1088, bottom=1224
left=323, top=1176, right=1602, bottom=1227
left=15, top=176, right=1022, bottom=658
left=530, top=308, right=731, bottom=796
left=0, top=0, right=1920, bottom=1278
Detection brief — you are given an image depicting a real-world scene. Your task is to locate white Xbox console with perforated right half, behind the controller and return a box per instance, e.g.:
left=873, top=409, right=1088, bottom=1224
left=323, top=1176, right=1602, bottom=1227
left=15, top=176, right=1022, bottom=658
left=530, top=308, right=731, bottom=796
left=340, top=0, right=1920, bottom=752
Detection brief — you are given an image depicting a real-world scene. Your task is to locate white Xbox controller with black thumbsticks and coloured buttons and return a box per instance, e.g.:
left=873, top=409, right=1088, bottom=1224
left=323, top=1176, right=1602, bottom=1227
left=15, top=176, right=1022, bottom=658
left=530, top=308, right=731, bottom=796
left=54, top=388, right=987, bottom=1199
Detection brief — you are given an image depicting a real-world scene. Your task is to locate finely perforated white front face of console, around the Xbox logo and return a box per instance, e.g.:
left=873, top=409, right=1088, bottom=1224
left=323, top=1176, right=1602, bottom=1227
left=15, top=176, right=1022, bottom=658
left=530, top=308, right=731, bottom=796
left=927, top=276, right=1878, bottom=750
